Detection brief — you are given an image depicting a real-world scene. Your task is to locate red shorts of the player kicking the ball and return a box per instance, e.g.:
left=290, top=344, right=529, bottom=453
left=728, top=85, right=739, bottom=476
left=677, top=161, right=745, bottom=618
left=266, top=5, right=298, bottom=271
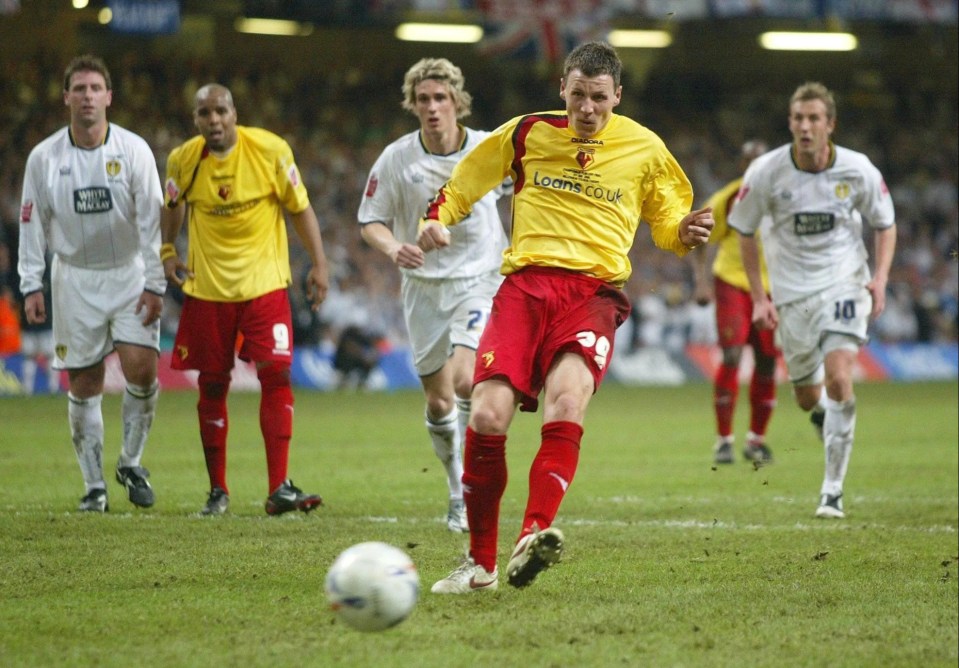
left=473, top=267, right=629, bottom=412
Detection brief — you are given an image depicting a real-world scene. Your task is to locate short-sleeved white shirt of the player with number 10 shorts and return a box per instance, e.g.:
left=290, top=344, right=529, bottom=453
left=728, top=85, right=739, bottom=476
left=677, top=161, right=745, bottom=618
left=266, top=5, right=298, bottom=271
left=729, top=144, right=896, bottom=304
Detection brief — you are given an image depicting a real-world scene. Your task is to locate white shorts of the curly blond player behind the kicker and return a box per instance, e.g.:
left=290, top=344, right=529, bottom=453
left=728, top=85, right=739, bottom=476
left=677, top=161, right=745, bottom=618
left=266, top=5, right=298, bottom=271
left=402, top=271, right=503, bottom=376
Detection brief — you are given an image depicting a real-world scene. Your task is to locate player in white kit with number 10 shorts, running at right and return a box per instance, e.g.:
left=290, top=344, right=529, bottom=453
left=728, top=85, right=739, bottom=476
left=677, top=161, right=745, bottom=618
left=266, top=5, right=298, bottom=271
left=729, top=83, right=896, bottom=518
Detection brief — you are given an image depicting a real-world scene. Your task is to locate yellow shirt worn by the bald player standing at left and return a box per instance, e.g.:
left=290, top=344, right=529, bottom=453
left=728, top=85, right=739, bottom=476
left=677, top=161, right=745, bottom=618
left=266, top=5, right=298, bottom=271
left=165, top=126, right=310, bottom=302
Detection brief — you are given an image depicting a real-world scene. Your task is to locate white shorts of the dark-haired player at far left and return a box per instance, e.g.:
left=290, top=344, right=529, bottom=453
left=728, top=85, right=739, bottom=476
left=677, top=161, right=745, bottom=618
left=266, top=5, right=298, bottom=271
left=50, top=256, right=160, bottom=369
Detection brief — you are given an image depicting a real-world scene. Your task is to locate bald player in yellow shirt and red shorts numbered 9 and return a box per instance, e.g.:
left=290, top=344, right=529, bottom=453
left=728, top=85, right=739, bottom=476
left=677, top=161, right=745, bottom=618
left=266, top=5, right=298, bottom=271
left=160, top=84, right=329, bottom=515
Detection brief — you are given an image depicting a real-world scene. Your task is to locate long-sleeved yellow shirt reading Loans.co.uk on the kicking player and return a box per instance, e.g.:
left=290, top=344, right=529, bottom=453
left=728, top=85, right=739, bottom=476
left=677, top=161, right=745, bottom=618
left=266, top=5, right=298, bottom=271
left=420, top=111, right=693, bottom=285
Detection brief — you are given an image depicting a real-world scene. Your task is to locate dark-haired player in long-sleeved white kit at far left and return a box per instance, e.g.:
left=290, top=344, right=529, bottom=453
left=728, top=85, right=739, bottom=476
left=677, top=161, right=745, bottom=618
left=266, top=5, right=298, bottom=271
left=18, top=55, right=166, bottom=512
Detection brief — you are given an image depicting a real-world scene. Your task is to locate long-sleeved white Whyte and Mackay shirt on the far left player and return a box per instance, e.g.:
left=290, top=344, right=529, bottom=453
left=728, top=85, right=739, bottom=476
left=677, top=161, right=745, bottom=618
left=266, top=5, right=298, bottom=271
left=18, top=123, right=166, bottom=295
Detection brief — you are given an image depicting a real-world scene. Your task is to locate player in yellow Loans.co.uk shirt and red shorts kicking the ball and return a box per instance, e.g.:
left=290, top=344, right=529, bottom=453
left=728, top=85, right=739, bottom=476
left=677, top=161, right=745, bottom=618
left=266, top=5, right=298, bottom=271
left=426, top=42, right=713, bottom=594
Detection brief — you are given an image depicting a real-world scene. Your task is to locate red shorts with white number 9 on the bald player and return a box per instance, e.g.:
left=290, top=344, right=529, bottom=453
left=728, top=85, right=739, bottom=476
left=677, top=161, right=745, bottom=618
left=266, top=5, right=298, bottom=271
left=170, top=290, right=293, bottom=373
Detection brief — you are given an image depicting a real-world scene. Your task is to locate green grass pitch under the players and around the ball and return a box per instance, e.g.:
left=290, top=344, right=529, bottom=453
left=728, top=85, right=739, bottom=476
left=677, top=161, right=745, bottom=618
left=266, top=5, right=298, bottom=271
left=0, top=382, right=959, bottom=667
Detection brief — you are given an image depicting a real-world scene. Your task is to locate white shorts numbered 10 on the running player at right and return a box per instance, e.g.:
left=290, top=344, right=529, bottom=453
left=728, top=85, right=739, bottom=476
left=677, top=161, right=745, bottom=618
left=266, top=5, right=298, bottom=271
left=776, top=272, right=872, bottom=385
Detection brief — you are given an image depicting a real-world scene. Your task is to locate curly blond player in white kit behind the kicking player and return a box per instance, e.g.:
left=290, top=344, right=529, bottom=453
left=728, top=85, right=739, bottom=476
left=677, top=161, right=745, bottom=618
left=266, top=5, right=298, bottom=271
left=358, top=58, right=511, bottom=532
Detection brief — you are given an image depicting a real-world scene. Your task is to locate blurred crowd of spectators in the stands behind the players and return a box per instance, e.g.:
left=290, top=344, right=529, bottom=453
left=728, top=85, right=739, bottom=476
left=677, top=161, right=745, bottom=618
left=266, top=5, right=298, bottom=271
left=0, top=53, right=959, bottom=366
